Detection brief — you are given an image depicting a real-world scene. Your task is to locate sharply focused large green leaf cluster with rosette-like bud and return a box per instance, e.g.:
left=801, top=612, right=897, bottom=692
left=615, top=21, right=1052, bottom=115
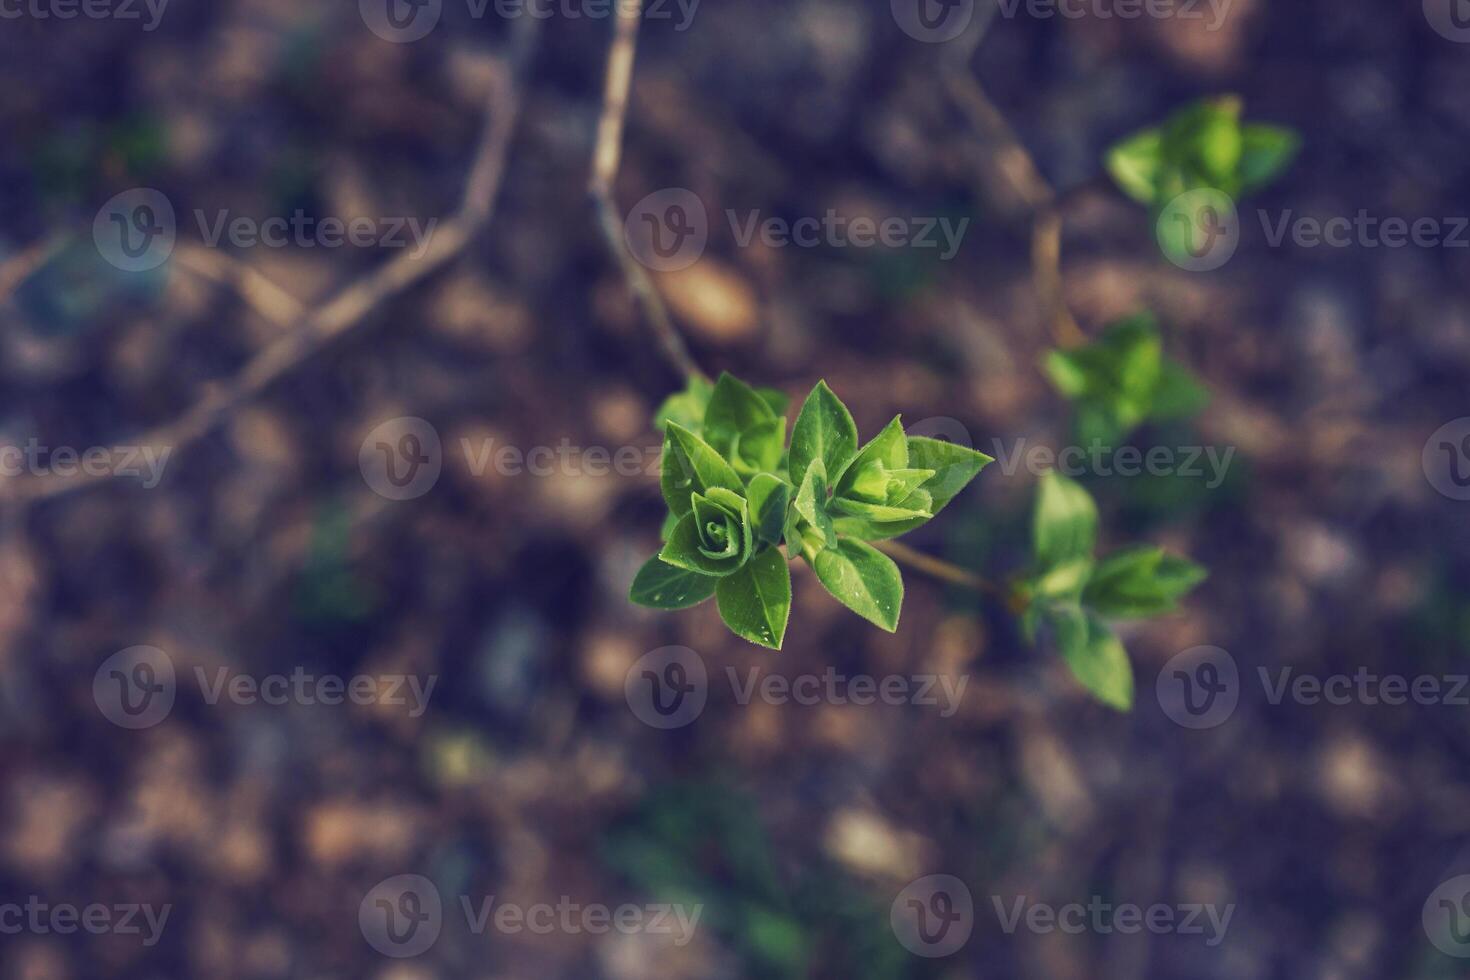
left=631, top=373, right=992, bottom=649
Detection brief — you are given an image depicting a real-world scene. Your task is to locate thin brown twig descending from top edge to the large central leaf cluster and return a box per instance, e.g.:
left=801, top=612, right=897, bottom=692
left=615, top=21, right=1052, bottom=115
left=587, top=0, right=706, bottom=378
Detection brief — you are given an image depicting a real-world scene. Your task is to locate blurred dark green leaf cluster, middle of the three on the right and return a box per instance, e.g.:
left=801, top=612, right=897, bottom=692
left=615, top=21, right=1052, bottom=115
left=1042, top=313, right=1208, bottom=445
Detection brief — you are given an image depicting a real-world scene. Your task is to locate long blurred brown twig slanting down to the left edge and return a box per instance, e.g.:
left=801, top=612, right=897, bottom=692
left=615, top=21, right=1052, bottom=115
left=9, top=18, right=539, bottom=502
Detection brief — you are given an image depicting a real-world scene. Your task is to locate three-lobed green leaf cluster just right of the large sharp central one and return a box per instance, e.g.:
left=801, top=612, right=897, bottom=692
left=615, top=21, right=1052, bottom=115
left=1017, top=472, right=1205, bottom=711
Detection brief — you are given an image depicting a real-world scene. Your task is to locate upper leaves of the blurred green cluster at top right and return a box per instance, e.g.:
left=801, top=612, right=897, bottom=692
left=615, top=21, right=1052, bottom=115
left=1104, top=96, right=1301, bottom=212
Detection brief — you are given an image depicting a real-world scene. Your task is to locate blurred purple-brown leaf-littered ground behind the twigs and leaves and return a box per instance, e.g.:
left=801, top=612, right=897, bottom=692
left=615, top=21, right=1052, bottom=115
left=0, top=0, right=1470, bottom=980
